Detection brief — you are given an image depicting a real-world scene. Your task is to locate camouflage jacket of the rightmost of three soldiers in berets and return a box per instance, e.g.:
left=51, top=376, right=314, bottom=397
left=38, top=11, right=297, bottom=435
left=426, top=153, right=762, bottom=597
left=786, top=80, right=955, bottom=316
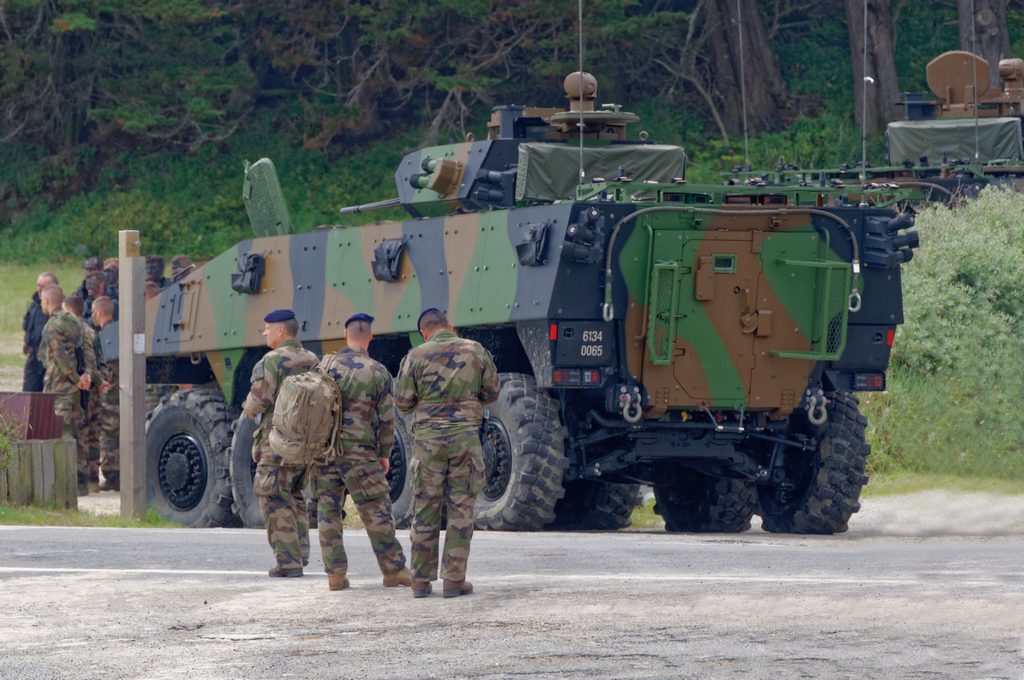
left=395, top=331, right=501, bottom=439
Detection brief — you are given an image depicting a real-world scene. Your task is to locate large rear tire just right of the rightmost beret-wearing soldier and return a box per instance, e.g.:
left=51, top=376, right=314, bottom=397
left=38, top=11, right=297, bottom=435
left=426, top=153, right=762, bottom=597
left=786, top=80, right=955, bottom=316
left=474, top=373, right=568, bottom=532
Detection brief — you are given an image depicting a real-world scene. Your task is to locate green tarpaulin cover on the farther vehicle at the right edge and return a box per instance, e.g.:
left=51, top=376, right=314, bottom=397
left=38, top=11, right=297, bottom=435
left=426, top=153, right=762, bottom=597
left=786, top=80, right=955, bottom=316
left=886, top=117, right=1024, bottom=165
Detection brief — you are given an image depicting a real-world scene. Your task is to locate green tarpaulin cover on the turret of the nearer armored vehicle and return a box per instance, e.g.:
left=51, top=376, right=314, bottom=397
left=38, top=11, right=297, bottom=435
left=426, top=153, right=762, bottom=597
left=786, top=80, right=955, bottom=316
left=515, top=143, right=686, bottom=201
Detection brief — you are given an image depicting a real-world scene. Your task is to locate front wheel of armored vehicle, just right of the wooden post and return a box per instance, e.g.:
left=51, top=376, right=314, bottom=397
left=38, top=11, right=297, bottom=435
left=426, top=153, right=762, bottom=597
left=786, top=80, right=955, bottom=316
left=145, top=389, right=239, bottom=526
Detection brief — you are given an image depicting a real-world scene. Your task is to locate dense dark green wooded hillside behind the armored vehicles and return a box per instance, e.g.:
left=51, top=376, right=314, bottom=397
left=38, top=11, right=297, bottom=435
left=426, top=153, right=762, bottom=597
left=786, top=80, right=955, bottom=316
left=0, top=0, right=1024, bottom=257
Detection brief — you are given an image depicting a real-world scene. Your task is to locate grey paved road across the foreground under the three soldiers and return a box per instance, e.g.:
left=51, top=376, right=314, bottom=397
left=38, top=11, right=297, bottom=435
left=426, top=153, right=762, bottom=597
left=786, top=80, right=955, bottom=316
left=0, top=527, right=1024, bottom=680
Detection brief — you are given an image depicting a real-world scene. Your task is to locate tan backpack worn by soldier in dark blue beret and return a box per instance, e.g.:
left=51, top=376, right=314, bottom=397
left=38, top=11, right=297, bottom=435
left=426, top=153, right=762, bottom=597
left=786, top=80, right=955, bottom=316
left=269, top=354, right=341, bottom=465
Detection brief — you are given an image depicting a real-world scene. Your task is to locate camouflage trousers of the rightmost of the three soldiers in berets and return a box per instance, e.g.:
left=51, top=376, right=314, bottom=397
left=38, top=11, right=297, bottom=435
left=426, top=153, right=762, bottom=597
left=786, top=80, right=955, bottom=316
left=409, top=432, right=483, bottom=581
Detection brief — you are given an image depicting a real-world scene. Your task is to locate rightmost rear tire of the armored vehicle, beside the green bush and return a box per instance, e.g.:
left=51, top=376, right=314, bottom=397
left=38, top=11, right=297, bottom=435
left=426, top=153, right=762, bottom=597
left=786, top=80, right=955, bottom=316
left=758, top=392, right=871, bottom=534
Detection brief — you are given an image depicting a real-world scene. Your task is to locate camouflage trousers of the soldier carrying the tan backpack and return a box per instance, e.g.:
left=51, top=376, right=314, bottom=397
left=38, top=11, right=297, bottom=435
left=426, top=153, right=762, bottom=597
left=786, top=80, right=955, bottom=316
left=253, top=463, right=309, bottom=569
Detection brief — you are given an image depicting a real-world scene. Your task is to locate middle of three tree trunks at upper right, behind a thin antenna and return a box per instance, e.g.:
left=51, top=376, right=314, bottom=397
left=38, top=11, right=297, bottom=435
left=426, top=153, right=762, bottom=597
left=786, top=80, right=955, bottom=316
left=845, top=0, right=900, bottom=136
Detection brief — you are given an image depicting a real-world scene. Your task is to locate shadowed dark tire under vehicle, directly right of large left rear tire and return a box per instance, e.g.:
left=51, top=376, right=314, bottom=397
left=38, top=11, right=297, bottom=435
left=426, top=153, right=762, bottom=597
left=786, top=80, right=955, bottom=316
left=545, top=479, right=640, bottom=532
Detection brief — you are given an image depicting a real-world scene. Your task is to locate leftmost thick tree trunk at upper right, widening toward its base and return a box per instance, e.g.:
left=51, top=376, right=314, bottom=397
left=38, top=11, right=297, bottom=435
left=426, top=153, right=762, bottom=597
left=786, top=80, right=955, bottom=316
left=709, top=0, right=785, bottom=134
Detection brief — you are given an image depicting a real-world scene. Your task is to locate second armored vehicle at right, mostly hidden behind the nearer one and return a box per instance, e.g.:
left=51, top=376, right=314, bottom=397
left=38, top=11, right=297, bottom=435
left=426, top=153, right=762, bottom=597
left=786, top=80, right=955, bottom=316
left=726, top=51, right=1024, bottom=204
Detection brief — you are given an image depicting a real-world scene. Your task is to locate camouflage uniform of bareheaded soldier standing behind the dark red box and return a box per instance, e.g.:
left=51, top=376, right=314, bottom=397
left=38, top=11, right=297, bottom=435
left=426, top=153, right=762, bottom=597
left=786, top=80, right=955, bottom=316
left=39, top=309, right=96, bottom=473
